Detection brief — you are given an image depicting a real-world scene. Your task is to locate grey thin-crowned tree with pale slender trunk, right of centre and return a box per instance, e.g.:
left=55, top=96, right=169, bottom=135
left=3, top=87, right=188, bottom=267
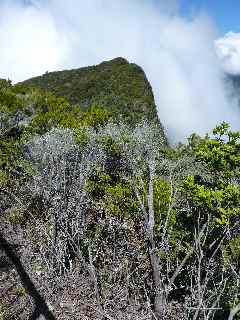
left=101, top=122, right=199, bottom=317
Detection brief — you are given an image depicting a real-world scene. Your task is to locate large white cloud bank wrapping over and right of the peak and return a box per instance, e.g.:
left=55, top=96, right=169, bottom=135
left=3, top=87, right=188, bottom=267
left=0, top=0, right=239, bottom=142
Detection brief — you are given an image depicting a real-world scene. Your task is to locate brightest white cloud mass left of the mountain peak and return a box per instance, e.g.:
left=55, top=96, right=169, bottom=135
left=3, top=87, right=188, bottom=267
left=0, top=2, right=70, bottom=82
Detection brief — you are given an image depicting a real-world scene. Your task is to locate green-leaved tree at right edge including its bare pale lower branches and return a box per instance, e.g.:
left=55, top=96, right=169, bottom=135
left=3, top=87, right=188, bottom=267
left=182, top=123, right=240, bottom=319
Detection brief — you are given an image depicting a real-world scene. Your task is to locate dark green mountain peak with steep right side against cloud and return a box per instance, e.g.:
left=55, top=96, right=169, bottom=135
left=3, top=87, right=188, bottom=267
left=22, top=58, right=163, bottom=127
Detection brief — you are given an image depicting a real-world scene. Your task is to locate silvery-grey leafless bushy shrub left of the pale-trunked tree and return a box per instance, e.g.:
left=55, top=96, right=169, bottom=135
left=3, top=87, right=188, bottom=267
left=26, top=129, right=103, bottom=273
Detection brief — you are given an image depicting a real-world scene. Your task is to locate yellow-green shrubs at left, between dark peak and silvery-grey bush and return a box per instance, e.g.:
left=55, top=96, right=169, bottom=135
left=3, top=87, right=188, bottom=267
left=0, top=80, right=111, bottom=185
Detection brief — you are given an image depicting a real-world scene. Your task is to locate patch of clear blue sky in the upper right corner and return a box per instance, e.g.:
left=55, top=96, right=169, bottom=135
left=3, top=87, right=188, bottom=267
left=180, top=0, right=240, bottom=34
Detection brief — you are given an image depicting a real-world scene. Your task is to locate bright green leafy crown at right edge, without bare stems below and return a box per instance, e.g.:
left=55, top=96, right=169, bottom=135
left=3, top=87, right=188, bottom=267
left=183, top=123, right=240, bottom=224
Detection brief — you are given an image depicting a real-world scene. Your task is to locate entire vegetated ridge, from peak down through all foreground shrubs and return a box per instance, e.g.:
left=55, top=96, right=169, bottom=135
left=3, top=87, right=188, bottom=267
left=0, top=59, right=240, bottom=320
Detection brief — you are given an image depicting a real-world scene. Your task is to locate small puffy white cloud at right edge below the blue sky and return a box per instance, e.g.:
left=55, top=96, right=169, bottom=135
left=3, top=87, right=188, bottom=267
left=215, top=32, right=240, bottom=75
